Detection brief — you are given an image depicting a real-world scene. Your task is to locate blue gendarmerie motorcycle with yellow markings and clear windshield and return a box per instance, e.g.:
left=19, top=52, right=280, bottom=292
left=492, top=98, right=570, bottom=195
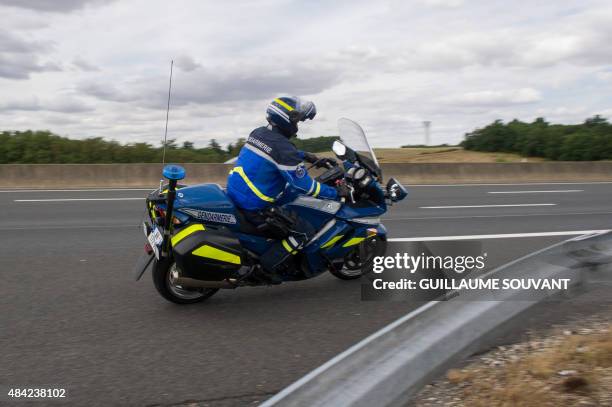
left=133, top=119, right=407, bottom=304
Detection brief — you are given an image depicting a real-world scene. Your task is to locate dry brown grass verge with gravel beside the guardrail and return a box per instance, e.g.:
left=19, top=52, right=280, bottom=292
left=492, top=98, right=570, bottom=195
left=415, top=321, right=612, bottom=407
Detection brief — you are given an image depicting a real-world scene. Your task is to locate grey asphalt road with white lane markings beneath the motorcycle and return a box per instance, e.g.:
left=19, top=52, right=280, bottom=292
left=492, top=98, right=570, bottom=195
left=0, top=183, right=612, bottom=406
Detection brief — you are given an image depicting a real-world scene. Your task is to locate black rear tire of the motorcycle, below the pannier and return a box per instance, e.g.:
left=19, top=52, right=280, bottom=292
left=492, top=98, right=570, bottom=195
left=151, top=259, right=219, bottom=304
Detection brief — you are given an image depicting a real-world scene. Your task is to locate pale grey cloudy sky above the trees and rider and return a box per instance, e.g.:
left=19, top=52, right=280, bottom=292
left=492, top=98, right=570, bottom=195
left=0, top=0, right=612, bottom=146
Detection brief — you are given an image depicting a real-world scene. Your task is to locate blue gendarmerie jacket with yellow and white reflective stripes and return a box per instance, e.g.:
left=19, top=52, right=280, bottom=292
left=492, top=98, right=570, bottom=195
left=227, top=127, right=338, bottom=210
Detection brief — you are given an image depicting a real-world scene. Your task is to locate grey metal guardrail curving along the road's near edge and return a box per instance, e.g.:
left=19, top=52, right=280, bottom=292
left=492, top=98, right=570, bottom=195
left=261, top=232, right=612, bottom=407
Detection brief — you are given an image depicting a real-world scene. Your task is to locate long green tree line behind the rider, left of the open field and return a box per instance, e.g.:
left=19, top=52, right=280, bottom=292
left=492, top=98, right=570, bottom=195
left=0, top=130, right=336, bottom=164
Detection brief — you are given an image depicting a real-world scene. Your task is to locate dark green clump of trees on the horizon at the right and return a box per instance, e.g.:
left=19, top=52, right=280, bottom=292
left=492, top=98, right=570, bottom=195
left=461, top=116, right=612, bottom=161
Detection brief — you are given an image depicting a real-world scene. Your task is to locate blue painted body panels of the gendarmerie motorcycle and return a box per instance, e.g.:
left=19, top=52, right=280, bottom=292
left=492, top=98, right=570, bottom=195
left=164, top=182, right=387, bottom=277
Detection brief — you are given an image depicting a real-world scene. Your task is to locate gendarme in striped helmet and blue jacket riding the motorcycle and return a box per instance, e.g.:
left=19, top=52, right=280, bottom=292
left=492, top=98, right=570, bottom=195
left=227, top=96, right=350, bottom=282
